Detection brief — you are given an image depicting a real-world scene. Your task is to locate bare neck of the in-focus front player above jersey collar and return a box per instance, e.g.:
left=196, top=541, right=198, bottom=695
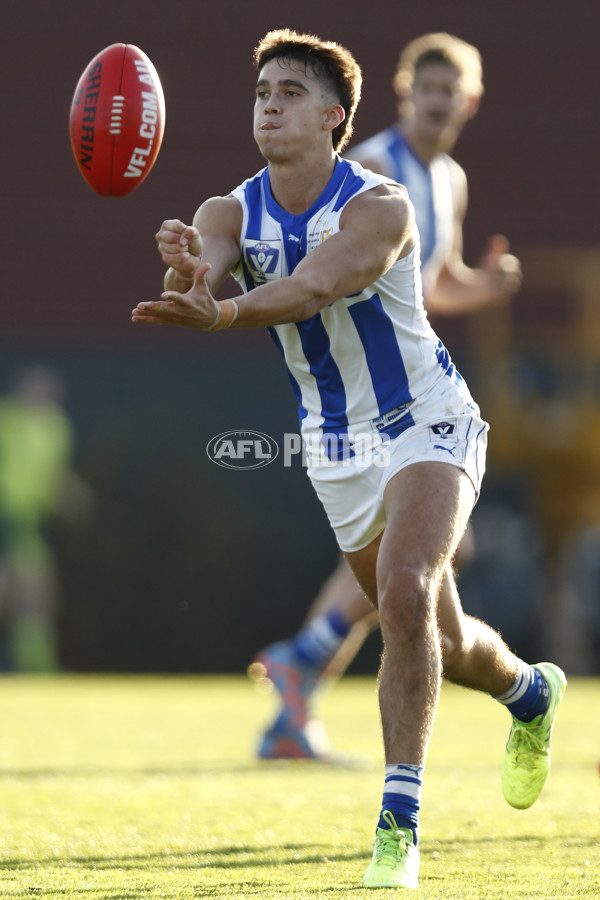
left=269, top=154, right=337, bottom=215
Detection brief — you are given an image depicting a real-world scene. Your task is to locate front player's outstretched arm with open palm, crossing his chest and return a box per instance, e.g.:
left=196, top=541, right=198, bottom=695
left=140, top=184, right=414, bottom=330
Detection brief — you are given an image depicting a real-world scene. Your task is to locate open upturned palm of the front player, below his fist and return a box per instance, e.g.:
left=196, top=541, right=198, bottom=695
left=131, top=263, right=219, bottom=330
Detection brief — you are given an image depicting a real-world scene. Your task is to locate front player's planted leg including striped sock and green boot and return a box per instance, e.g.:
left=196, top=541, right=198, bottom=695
left=347, top=462, right=475, bottom=887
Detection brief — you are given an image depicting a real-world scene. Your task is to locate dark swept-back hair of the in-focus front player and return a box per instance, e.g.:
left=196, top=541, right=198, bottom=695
left=254, top=28, right=362, bottom=153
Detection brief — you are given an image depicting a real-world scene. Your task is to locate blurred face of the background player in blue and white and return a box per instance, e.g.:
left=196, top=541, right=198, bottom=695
left=411, top=63, right=469, bottom=137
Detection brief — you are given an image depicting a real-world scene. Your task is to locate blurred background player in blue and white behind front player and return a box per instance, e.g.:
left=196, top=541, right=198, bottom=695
left=248, top=33, right=521, bottom=759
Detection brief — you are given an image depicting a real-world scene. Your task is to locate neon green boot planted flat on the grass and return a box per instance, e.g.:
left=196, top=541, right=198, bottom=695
left=363, top=810, right=420, bottom=889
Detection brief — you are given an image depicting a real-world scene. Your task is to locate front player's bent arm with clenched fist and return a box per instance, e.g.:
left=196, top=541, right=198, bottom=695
left=155, top=196, right=242, bottom=293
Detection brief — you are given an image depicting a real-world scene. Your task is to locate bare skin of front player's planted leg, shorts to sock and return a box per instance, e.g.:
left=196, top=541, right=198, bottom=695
left=347, top=463, right=475, bottom=764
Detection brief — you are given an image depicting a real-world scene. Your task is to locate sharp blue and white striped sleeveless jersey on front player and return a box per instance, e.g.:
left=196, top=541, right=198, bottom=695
left=232, top=159, right=469, bottom=450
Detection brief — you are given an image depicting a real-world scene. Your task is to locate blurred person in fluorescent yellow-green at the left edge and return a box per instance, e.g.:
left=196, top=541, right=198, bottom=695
left=0, top=366, right=91, bottom=672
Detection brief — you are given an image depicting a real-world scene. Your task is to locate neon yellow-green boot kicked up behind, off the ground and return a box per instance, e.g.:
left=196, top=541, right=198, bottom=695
left=502, top=663, right=567, bottom=809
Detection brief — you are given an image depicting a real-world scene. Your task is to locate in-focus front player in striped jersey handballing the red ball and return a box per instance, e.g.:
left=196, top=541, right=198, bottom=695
left=132, top=29, right=565, bottom=889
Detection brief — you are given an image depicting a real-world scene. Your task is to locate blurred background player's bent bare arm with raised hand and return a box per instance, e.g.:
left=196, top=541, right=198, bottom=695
left=425, top=165, right=521, bottom=316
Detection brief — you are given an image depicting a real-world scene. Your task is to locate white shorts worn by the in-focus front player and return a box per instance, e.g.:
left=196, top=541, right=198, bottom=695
left=305, top=379, right=489, bottom=552
